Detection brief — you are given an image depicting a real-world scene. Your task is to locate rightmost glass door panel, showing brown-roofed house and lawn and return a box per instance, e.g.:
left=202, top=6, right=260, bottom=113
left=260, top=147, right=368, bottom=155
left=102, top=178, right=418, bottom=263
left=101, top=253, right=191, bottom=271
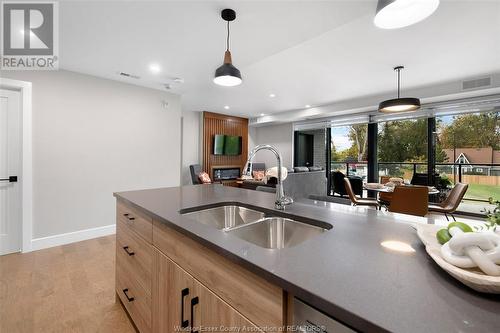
left=436, top=112, right=500, bottom=214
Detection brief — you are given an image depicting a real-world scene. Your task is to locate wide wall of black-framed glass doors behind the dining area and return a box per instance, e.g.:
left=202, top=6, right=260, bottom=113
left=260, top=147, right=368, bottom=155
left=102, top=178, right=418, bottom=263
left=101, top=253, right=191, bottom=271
left=294, top=101, right=500, bottom=214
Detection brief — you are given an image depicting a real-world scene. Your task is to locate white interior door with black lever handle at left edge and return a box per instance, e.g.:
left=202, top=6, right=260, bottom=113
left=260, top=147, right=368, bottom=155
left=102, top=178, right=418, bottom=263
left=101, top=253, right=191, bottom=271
left=0, top=89, right=22, bottom=255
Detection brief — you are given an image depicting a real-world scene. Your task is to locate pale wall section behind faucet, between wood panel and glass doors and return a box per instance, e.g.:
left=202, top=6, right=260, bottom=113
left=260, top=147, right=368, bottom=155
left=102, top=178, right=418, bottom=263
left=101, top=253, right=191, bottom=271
left=249, top=123, right=293, bottom=168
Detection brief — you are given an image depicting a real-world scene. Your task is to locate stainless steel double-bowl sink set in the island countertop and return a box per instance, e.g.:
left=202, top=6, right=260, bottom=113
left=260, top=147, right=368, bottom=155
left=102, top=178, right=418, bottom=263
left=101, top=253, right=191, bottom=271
left=181, top=205, right=331, bottom=249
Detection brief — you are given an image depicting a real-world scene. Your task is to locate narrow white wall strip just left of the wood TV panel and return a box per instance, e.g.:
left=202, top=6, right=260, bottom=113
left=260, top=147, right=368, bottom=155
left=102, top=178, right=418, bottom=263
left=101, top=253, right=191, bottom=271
left=181, top=111, right=202, bottom=185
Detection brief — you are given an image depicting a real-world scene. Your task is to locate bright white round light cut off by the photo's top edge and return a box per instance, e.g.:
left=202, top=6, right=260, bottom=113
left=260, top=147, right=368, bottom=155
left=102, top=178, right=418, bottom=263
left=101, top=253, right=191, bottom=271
left=373, top=0, right=439, bottom=29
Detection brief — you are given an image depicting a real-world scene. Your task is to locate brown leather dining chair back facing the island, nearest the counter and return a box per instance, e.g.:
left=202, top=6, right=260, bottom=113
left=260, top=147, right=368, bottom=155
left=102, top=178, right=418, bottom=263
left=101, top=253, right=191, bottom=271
left=389, top=186, right=429, bottom=216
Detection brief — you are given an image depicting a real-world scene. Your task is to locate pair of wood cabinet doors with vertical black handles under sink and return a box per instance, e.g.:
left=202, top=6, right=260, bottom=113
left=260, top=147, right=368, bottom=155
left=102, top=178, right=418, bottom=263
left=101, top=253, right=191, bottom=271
left=152, top=250, right=257, bottom=333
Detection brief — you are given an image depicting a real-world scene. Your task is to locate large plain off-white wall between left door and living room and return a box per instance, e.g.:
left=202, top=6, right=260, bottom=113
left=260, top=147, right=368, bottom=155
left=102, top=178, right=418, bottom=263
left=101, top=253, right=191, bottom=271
left=1, top=71, right=181, bottom=238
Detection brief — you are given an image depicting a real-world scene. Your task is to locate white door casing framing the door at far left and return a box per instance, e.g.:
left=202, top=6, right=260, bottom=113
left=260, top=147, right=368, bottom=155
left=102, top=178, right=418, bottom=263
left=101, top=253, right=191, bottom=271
left=0, top=77, right=33, bottom=252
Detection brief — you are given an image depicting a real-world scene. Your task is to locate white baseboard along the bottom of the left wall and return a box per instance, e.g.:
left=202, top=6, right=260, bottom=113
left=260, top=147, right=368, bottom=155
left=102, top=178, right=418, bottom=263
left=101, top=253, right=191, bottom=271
left=31, top=224, right=116, bottom=251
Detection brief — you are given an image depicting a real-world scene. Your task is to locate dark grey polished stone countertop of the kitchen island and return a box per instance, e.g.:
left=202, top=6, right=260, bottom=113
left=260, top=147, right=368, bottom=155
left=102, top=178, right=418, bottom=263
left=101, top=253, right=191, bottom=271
left=115, top=185, right=500, bottom=333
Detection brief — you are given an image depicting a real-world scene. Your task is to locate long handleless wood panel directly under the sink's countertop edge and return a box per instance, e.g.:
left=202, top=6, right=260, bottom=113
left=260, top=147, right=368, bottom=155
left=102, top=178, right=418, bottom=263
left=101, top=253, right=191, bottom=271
left=153, top=221, right=286, bottom=327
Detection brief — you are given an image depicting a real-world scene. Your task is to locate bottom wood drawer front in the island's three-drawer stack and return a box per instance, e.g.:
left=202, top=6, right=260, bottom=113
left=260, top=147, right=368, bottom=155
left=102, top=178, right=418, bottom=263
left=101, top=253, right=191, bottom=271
left=116, top=262, right=151, bottom=333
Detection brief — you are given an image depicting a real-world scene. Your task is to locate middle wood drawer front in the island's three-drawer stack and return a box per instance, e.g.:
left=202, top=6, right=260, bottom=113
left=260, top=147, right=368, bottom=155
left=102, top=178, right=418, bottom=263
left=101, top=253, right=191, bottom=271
left=116, top=219, right=153, bottom=295
